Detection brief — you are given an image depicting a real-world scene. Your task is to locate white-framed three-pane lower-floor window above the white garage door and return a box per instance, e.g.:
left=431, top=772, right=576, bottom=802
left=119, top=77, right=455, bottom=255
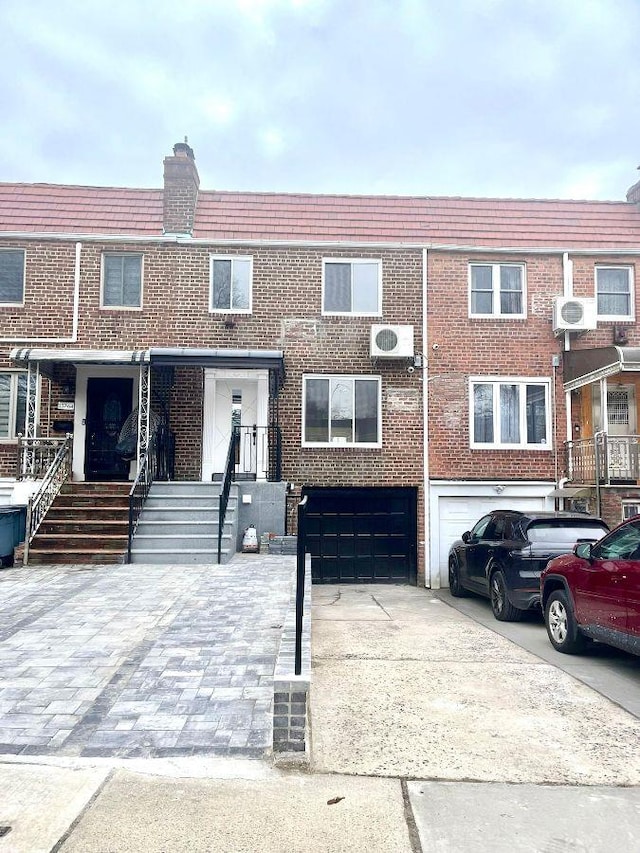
left=469, top=377, right=551, bottom=450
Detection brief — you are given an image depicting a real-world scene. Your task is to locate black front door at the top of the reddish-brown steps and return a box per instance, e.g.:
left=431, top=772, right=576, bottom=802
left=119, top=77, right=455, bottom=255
left=84, top=378, right=133, bottom=481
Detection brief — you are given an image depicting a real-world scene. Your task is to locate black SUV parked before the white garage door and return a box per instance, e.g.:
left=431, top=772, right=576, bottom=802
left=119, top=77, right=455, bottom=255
left=449, top=509, right=609, bottom=622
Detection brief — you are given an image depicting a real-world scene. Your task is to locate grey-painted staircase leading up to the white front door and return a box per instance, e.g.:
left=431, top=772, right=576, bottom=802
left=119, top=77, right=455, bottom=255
left=131, top=482, right=238, bottom=565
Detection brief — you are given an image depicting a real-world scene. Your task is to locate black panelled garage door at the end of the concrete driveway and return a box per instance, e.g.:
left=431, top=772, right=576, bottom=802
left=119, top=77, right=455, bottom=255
left=303, top=488, right=417, bottom=583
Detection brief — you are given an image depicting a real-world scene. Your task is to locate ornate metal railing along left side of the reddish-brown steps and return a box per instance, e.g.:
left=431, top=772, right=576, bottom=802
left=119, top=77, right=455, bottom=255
left=20, top=435, right=73, bottom=566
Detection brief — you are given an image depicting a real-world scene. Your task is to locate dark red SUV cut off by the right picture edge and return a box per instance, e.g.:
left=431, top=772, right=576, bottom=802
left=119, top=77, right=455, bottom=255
left=540, top=515, right=640, bottom=655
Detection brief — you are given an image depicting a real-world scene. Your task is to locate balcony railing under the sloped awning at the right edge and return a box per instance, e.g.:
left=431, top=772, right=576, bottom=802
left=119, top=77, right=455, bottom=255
left=565, top=433, right=640, bottom=486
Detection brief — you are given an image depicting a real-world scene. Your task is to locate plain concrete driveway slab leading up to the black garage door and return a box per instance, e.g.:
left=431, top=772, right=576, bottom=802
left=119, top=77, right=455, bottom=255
left=311, top=586, right=640, bottom=786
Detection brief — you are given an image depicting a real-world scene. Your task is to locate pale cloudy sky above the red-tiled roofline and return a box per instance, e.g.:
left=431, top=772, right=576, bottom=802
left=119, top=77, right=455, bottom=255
left=0, top=0, right=640, bottom=201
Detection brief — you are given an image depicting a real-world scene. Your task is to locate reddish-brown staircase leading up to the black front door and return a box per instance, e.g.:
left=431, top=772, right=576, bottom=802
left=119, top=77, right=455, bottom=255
left=28, top=483, right=131, bottom=565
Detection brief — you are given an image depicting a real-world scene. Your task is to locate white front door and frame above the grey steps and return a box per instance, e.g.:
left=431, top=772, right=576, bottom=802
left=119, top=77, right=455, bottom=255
left=202, top=370, right=269, bottom=482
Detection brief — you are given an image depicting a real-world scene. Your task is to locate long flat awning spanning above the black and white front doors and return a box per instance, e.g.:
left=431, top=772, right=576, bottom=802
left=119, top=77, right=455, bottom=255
left=10, top=347, right=284, bottom=387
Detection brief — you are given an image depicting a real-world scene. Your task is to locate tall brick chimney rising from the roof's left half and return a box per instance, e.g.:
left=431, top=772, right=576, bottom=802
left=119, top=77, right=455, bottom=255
left=163, top=136, right=200, bottom=234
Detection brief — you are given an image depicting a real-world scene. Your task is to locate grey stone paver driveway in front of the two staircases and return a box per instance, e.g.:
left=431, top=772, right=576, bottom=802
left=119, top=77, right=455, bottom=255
left=0, top=555, right=295, bottom=757
